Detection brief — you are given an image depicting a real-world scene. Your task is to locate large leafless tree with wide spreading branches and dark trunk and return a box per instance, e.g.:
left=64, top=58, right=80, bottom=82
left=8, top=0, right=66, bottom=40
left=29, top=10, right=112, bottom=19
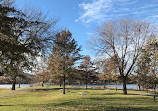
left=90, top=19, right=154, bottom=94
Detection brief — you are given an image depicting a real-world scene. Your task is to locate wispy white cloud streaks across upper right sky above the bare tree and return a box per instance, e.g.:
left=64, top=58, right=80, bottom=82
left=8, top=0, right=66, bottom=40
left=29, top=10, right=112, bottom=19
left=75, top=0, right=158, bottom=23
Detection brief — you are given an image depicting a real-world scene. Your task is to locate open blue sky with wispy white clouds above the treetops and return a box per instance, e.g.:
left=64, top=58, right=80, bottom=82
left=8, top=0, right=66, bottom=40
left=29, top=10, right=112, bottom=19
left=16, top=0, right=158, bottom=58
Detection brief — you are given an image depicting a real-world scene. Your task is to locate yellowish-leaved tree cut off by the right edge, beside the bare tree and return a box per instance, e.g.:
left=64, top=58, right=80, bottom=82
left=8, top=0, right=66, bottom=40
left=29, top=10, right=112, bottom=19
left=135, top=35, right=158, bottom=101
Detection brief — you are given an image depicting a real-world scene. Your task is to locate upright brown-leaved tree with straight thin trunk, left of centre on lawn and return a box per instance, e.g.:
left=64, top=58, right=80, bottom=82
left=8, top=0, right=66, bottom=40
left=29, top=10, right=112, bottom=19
left=48, top=30, right=81, bottom=94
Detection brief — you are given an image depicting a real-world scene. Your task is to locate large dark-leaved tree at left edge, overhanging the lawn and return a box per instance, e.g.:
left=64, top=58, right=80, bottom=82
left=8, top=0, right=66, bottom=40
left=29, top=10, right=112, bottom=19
left=0, top=0, right=56, bottom=90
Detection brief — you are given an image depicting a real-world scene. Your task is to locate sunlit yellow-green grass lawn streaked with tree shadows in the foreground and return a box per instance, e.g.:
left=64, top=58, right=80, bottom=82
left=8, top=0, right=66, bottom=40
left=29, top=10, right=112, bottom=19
left=0, top=86, right=158, bottom=111
